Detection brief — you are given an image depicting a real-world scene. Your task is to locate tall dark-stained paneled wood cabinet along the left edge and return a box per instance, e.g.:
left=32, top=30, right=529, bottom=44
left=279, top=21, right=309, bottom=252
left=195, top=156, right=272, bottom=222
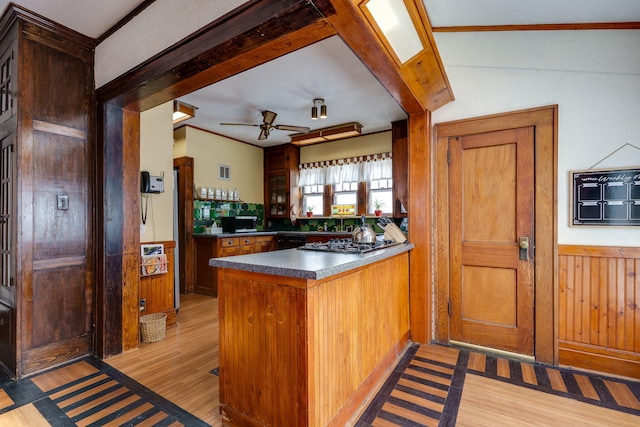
left=0, top=4, right=95, bottom=378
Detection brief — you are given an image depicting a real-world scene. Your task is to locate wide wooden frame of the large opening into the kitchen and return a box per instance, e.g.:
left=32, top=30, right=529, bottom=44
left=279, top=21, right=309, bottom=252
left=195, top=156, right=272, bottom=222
left=95, top=0, right=444, bottom=357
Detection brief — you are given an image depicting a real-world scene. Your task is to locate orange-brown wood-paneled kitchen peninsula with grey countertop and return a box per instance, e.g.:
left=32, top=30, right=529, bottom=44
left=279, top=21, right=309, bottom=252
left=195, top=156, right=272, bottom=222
left=209, top=243, right=414, bottom=427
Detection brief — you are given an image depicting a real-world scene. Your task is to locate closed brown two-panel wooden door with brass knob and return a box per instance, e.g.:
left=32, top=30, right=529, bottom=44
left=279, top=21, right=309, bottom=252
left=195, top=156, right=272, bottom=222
left=449, top=127, right=534, bottom=355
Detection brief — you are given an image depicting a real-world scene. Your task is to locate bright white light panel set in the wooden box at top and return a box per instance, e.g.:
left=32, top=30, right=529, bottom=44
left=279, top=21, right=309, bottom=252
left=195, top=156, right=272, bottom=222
left=365, top=0, right=424, bottom=64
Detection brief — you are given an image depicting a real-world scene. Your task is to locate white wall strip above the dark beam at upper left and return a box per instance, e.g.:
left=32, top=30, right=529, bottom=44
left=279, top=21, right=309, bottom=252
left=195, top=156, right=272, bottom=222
left=95, top=0, right=247, bottom=88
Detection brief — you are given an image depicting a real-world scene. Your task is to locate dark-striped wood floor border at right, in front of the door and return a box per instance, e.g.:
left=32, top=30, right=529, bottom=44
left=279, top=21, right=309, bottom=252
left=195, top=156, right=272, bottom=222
left=356, top=344, right=640, bottom=427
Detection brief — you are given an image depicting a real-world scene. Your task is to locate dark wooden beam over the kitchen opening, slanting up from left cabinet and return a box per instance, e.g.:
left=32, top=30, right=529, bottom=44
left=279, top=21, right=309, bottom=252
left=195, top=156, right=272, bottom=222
left=97, top=0, right=335, bottom=111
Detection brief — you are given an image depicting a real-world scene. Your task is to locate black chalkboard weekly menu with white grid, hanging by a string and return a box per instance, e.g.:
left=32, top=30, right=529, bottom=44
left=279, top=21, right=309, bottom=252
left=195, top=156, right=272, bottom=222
left=570, top=168, right=640, bottom=226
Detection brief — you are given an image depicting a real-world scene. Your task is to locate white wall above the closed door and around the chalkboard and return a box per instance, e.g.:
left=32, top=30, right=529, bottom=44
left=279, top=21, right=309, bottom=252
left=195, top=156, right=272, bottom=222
left=433, top=30, right=640, bottom=247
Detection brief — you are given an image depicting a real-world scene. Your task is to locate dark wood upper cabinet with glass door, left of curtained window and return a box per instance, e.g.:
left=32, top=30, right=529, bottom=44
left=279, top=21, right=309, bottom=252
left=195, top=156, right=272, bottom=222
left=264, top=144, right=300, bottom=218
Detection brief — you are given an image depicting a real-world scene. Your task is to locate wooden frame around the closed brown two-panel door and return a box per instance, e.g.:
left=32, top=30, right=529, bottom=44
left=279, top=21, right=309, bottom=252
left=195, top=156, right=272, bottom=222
left=433, top=105, right=558, bottom=364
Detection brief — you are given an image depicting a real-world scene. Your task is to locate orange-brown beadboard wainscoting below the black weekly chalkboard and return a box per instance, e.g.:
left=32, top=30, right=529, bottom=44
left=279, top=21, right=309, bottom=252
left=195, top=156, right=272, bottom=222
left=558, top=245, right=640, bottom=378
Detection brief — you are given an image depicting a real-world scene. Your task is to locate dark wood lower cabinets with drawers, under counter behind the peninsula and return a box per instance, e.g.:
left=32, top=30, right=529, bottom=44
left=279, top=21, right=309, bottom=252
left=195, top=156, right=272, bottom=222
left=193, top=235, right=277, bottom=297
